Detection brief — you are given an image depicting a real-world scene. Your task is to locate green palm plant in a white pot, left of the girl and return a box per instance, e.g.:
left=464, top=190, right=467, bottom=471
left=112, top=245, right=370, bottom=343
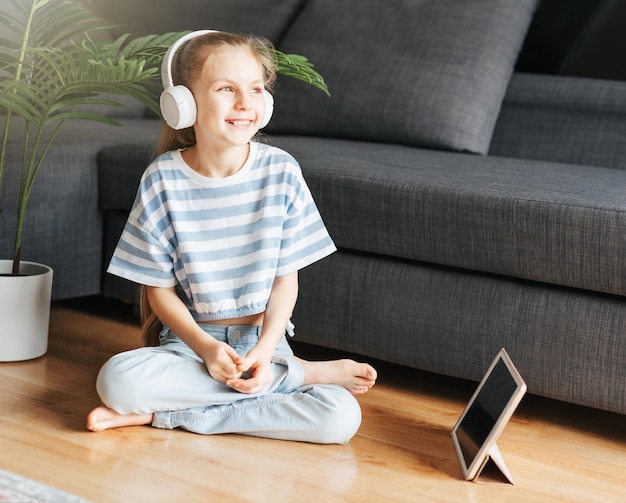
left=0, top=0, right=328, bottom=361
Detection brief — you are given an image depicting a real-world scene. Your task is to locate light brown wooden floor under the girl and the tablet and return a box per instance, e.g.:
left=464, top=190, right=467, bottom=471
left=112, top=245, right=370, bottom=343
left=0, top=299, right=626, bottom=503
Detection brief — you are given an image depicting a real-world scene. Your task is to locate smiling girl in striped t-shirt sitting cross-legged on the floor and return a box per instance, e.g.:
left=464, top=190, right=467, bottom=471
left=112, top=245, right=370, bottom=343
left=87, top=32, right=376, bottom=443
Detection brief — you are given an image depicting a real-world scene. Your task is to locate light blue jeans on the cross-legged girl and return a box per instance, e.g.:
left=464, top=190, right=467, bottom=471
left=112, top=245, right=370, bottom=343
left=96, top=324, right=361, bottom=444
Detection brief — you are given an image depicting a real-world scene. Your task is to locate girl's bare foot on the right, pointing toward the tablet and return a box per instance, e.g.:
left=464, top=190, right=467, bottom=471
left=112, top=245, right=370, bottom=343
left=299, top=359, right=377, bottom=395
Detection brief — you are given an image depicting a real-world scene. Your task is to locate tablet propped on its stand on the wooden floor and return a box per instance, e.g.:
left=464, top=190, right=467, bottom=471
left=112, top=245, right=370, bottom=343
left=451, top=348, right=526, bottom=483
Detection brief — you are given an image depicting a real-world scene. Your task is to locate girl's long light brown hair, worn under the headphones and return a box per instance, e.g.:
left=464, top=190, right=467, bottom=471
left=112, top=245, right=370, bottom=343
left=139, top=32, right=277, bottom=346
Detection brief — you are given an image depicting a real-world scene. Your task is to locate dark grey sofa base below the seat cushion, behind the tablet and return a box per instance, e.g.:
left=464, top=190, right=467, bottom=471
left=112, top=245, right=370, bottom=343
left=294, top=250, right=626, bottom=414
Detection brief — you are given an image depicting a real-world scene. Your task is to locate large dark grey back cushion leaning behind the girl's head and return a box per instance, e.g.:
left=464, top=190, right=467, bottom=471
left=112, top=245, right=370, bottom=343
left=269, top=0, right=536, bottom=153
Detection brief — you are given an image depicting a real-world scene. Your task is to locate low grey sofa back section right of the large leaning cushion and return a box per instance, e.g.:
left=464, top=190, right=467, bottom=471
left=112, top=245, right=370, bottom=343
left=489, top=73, right=626, bottom=169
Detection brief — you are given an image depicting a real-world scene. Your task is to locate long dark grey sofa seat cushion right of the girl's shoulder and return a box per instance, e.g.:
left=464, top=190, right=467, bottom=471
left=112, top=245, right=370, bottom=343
left=273, top=137, right=626, bottom=295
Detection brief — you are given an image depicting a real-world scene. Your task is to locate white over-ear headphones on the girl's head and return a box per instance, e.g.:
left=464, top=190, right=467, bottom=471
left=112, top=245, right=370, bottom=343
left=160, top=30, right=274, bottom=129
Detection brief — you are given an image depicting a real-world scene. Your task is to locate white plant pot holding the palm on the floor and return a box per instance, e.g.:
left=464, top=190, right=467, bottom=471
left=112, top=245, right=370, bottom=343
left=0, top=260, right=52, bottom=362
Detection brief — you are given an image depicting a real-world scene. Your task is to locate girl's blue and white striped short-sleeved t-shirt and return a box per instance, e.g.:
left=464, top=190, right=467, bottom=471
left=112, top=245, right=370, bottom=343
left=108, top=142, right=336, bottom=321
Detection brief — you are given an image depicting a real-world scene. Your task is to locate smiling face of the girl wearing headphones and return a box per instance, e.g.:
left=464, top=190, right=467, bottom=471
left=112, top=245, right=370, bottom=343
left=192, top=47, right=265, bottom=152
